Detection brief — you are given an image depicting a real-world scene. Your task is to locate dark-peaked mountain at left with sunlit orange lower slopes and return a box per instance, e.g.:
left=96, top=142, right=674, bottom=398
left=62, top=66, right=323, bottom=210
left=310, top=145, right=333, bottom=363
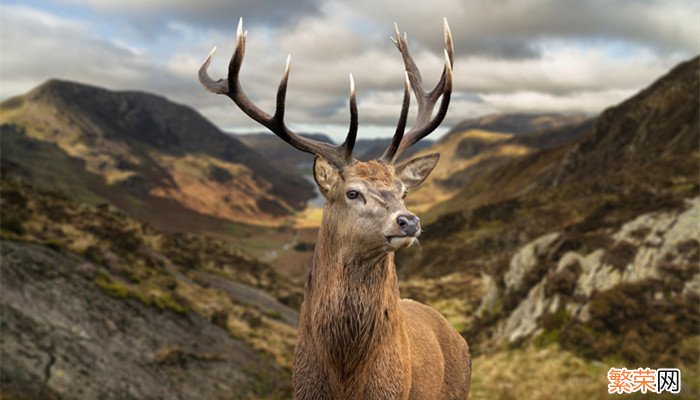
left=0, top=80, right=313, bottom=232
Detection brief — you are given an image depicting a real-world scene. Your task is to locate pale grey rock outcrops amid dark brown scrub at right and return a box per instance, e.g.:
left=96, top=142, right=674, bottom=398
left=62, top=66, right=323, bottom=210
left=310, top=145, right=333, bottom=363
left=475, top=197, right=700, bottom=354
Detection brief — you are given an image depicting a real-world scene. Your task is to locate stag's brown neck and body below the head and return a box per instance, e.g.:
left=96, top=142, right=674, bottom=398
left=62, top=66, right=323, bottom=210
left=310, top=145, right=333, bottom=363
left=294, top=198, right=471, bottom=399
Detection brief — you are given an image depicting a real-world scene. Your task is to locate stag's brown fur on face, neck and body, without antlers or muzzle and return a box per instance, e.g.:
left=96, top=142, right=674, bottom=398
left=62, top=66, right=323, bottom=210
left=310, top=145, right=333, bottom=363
left=293, top=160, right=471, bottom=399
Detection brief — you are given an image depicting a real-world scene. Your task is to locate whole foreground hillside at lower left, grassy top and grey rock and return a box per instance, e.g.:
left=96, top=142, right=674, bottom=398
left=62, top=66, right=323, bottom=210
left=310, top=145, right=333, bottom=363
left=0, top=172, right=301, bottom=399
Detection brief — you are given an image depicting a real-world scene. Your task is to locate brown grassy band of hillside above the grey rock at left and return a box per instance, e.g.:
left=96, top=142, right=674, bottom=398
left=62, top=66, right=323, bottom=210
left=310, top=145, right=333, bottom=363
left=0, top=173, right=301, bottom=376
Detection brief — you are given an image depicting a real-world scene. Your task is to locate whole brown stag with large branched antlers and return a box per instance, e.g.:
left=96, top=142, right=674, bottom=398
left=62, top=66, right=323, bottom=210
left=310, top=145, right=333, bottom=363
left=199, top=19, right=471, bottom=400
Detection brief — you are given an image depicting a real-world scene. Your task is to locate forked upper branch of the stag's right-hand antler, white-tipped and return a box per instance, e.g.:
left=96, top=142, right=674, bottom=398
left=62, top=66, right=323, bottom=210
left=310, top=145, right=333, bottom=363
left=387, top=19, right=454, bottom=162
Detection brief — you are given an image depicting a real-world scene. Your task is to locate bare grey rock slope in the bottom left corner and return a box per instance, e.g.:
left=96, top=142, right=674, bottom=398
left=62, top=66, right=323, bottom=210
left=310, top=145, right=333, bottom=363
left=0, top=241, right=288, bottom=399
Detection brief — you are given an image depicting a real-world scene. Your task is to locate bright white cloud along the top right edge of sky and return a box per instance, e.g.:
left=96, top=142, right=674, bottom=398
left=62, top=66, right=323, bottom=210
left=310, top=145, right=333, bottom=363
left=348, top=0, right=700, bottom=58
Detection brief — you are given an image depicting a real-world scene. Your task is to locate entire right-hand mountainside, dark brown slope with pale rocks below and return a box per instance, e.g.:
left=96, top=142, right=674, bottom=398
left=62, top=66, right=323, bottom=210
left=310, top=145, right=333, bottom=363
left=397, top=57, right=700, bottom=388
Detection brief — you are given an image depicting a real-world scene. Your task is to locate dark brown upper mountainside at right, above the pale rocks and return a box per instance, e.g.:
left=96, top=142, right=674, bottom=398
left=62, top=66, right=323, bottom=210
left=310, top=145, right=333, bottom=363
left=422, top=56, right=697, bottom=225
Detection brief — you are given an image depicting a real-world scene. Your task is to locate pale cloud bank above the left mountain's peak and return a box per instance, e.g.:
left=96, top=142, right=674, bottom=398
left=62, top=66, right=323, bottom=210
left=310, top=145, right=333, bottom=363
left=1, top=5, right=227, bottom=115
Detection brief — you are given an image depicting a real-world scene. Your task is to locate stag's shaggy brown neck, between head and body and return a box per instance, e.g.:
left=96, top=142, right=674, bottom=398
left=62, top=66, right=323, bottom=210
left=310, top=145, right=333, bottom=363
left=302, top=219, right=403, bottom=380
